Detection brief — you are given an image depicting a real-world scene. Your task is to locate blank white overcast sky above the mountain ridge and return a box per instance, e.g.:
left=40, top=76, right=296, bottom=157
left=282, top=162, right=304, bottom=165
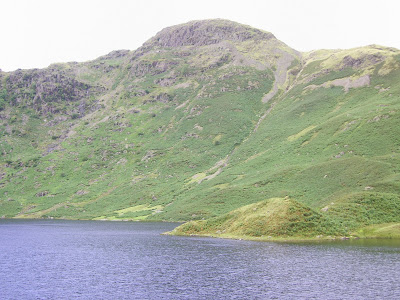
left=0, top=0, right=400, bottom=71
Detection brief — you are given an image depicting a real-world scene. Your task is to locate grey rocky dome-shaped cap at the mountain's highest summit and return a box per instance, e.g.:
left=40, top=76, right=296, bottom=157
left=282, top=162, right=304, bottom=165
left=144, top=20, right=275, bottom=47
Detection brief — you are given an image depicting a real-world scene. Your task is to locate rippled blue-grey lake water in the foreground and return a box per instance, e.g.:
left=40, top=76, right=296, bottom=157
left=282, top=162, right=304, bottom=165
left=0, top=220, right=400, bottom=299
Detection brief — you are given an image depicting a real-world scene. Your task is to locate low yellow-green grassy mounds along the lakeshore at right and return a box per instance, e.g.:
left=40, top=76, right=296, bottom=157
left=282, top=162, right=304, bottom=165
left=169, top=193, right=400, bottom=240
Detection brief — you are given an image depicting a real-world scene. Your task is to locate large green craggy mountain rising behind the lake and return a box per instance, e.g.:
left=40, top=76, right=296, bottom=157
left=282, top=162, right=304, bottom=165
left=0, top=19, right=400, bottom=239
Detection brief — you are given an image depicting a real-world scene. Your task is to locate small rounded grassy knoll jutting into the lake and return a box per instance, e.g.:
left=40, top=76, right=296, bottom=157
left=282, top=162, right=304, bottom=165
left=170, top=198, right=344, bottom=240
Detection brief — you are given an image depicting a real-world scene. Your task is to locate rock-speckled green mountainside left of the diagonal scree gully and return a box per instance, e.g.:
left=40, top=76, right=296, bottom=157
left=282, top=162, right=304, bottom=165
left=1, top=28, right=282, bottom=219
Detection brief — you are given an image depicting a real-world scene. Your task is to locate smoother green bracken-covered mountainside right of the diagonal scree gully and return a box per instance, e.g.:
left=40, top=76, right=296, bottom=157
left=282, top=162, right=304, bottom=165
left=170, top=47, right=400, bottom=236
